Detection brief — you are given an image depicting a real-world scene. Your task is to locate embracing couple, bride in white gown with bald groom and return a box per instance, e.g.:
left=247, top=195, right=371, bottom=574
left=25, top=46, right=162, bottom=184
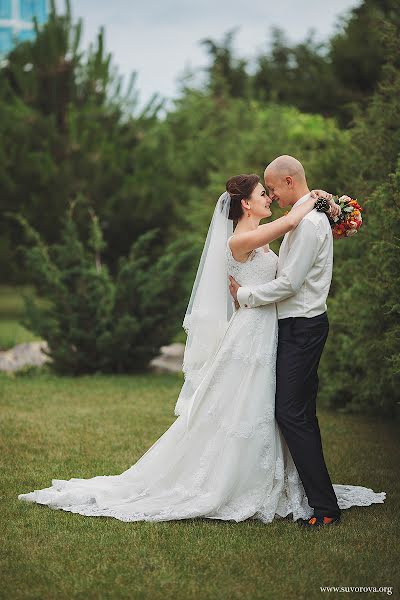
left=18, top=156, right=386, bottom=528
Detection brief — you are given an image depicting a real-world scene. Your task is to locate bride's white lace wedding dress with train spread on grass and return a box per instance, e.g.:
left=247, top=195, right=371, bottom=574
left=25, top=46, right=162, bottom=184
left=18, top=239, right=386, bottom=523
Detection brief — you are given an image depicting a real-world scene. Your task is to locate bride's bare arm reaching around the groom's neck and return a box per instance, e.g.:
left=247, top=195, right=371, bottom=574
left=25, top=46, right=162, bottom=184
left=230, top=190, right=332, bottom=255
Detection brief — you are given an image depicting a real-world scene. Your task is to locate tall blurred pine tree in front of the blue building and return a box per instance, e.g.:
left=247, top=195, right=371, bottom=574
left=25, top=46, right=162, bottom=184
left=0, top=3, right=166, bottom=280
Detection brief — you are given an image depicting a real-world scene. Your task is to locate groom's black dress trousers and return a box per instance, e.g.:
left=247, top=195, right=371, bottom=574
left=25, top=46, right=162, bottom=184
left=275, top=312, right=340, bottom=516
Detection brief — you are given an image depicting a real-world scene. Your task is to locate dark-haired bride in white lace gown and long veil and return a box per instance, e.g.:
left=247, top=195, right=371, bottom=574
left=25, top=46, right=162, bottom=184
left=18, top=175, right=385, bottom=523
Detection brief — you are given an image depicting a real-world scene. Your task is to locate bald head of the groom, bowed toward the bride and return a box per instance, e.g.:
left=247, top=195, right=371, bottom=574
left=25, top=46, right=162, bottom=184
left=264, top=154, right=309, bottom=208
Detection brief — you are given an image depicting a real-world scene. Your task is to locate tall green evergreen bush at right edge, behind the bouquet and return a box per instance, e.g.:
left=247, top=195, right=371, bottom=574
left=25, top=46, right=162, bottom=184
left=321, top=26, right=400, bottom=416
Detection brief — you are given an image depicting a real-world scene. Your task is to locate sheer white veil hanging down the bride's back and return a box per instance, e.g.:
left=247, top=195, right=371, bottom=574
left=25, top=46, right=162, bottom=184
left=175, top=192, right=233, bottom=416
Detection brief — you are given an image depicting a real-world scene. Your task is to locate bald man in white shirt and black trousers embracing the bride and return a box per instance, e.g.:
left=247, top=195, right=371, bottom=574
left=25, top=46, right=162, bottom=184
left=230, top=155, right=341, bottom=528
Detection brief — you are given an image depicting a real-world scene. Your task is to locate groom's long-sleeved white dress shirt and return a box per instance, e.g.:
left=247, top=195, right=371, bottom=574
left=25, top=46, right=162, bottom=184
left=237, top=194, right=333, bottom=319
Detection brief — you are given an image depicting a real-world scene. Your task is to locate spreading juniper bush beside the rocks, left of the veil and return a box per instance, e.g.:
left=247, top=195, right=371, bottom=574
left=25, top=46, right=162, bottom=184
left=10, top=206, right=193, bottom=375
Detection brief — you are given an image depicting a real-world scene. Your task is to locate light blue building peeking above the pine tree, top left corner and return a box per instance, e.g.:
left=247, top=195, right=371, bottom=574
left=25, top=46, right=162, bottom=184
left=0, top=0, right=48, bottom=56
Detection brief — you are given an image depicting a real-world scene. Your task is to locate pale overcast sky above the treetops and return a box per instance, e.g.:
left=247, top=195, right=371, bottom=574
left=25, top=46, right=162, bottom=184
left=57, top=0, right=360, bottom=103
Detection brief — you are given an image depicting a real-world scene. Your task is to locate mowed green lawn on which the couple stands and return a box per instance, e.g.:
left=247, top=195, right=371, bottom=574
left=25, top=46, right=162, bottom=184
left=0, top=371, right=400, bottom=600
